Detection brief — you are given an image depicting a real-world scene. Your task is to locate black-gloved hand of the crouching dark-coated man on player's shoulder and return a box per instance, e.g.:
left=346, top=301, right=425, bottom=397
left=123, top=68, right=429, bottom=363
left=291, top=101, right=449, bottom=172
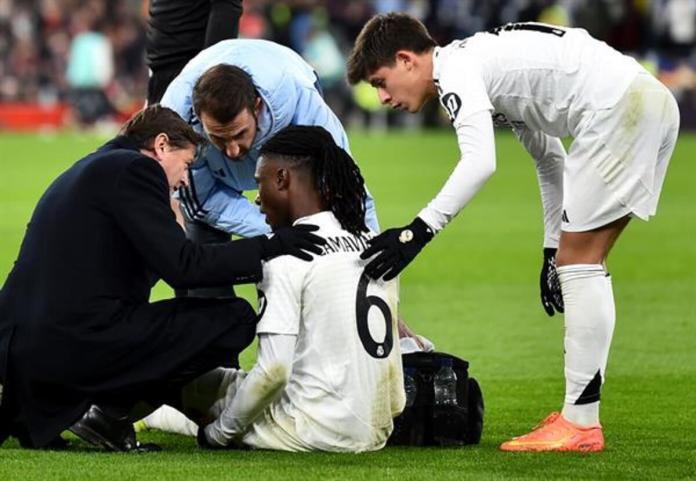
left=257, top=224, right=326, bottom=261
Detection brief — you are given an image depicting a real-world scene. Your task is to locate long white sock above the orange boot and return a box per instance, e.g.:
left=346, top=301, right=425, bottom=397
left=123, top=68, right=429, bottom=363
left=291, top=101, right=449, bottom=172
left=558, top=264, right=616, bottom=426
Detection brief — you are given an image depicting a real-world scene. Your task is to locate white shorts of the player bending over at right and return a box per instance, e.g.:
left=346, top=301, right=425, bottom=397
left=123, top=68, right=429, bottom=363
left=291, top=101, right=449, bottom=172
left=561, top=72, right=679, bottom=232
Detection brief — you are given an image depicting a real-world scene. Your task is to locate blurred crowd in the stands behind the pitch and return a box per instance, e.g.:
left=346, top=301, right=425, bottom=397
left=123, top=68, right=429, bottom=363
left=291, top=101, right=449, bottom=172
left=0, top=0, right=696, bottom=127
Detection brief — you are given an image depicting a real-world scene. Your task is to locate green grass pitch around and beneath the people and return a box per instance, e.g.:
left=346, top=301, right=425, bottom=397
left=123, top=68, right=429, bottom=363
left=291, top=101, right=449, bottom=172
left=0, top=132, right=696, bottom=480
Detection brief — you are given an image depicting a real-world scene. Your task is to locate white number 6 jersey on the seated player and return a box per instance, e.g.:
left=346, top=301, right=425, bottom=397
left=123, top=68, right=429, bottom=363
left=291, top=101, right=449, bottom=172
left=250, top=212, right=405, bottom=452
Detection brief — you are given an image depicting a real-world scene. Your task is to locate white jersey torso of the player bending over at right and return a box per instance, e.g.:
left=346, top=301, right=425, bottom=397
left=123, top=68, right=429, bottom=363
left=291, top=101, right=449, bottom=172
left=433, top=23, right=643, bottom=137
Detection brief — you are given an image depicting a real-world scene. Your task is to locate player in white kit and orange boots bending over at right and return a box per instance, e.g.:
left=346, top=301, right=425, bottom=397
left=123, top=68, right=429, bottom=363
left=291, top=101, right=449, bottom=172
left=348, top=13, right=679, bottom=451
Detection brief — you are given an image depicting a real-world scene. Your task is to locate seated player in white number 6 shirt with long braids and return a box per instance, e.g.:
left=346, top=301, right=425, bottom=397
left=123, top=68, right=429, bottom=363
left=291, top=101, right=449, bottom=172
left=199, top=126, right=405, bottom=452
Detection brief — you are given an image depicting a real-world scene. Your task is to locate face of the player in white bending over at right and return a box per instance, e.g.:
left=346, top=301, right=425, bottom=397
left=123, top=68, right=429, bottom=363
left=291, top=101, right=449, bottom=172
left=367, top=52, right=429, bottom=113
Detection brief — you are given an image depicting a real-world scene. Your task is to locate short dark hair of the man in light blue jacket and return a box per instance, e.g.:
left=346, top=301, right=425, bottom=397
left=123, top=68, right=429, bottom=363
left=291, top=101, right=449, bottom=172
left=193, top=64, right=258, bottom=123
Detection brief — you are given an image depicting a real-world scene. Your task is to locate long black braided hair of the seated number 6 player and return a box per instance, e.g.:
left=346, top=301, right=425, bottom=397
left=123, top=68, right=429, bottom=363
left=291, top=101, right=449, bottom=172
left=261, top=125, right=367, bottom=235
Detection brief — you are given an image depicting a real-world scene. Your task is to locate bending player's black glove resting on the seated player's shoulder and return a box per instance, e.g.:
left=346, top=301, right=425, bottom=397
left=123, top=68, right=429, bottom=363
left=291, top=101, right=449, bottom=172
left=360, top=217, right=434, bottom=281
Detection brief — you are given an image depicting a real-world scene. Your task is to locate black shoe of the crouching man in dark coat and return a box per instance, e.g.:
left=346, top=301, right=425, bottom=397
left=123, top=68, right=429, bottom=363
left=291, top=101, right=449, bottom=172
left=70, top=404, right=160, bottom=452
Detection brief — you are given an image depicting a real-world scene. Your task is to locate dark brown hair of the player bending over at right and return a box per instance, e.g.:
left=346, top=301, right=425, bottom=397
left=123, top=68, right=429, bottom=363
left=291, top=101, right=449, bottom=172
left=347, top=12, right=437, bottom=85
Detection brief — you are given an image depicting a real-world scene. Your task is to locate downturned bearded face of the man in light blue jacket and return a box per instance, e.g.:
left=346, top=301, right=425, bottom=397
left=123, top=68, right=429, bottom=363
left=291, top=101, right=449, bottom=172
left=201, top=99, right=261, bottom=161
